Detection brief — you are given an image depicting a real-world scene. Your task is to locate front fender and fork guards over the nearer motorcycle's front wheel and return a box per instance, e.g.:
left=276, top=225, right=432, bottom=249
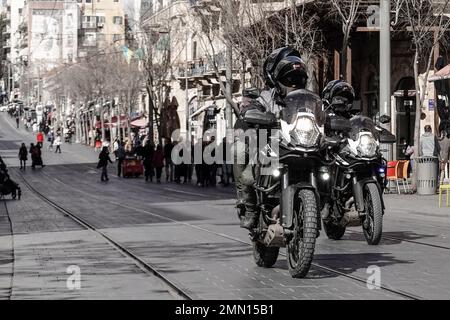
left=280, top=183, right=321, bottom=229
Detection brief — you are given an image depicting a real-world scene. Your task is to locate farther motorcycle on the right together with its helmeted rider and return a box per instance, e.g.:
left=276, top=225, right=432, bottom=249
left=322, top=81, right=396, bottom=245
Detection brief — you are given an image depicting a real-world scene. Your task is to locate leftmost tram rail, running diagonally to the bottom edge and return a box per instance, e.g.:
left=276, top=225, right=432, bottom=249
left=17, top=174, right=193, bottom=300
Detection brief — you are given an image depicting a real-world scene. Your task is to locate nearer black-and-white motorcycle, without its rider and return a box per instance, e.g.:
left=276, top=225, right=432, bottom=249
left=243, top=89, right=334, bottom=278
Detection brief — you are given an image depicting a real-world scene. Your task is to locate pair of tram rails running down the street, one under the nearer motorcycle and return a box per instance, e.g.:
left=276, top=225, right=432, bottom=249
left=14, top=173, right=428, bottom=300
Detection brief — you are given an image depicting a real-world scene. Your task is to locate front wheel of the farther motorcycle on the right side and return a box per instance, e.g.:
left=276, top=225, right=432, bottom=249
left=363, top=183, right=383, bottom=245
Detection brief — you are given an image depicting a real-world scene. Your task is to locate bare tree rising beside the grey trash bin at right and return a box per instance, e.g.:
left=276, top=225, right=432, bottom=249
left=397, top=0, right=450, bottom=189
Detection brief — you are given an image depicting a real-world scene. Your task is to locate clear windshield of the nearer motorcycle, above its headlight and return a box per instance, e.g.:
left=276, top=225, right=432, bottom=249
left=281, top=89, right=325, bottom=126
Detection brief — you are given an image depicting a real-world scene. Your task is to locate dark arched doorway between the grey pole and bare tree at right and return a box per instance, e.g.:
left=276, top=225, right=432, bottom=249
left=394, top=77, right=416, bottom=159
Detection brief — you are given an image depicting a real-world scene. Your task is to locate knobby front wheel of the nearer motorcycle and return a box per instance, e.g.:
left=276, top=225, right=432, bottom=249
left=287, top=189, right=318, bottom=278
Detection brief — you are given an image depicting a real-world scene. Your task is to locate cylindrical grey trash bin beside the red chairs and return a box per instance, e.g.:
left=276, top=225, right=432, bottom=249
left=416, top=157, right=439, bottom=195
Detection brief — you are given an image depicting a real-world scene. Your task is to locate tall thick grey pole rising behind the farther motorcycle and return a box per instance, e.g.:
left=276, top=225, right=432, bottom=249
left=380, top=0, right=392, bottom=160
